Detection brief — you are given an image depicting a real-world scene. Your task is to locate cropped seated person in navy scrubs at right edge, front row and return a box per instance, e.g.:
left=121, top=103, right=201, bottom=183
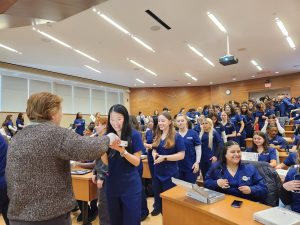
left=280, top=144, right=300, bottom=213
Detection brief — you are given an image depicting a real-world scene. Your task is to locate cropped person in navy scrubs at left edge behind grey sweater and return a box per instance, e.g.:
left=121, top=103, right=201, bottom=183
left=0, top=134, right=9, bottom=225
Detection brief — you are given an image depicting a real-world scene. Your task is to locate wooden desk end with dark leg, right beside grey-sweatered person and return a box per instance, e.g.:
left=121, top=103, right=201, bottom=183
left=72, top=172, right=97, bottom=225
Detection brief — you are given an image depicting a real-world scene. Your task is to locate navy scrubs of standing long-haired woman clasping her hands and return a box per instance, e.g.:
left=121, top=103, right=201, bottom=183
left=153, top=133, right=185, bottom=212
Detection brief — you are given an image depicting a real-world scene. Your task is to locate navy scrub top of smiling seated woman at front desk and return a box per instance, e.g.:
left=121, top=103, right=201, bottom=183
left=204, top=162, right=268, bottom=202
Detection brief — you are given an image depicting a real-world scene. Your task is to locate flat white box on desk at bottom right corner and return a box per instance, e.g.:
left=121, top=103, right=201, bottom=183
left=253, top=207, right=300, bottom=225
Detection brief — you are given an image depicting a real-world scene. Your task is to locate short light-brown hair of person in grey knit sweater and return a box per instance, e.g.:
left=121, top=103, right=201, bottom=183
left=26, top=92, right=62, bottom=121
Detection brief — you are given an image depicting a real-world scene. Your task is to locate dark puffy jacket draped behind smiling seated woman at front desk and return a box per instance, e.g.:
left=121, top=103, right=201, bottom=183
left=242, top=161, right=282, bottom=207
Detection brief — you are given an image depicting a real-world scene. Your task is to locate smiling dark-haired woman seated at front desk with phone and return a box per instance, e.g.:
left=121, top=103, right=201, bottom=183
left=204, top=141, right=268, bottom=201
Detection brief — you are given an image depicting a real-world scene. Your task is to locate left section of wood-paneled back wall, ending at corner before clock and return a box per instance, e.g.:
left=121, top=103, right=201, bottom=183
left=130, top=87, right=211, bottom=115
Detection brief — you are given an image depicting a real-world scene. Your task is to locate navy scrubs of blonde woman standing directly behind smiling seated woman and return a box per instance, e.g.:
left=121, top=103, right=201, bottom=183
left=200, top=130, right=223, bottom=179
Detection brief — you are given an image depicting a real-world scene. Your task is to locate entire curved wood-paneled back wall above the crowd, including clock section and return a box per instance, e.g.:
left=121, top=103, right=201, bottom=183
left=130, top=73, right=300, bottom=115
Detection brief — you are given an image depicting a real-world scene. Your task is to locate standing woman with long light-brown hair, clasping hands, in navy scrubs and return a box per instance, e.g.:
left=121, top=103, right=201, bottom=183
left=151, top=111, right=185, bottom=216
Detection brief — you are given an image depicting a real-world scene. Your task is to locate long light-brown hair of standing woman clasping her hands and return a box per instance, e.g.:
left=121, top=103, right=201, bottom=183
left=152, top=111, right=176, bottom=149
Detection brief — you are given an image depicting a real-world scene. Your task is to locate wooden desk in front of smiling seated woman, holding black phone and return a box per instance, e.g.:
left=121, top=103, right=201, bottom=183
left=161, top=186, right=270, bottom=225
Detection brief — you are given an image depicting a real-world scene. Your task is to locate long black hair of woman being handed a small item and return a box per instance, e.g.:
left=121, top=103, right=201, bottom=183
left=106, top=104, right=133, bottom=153
